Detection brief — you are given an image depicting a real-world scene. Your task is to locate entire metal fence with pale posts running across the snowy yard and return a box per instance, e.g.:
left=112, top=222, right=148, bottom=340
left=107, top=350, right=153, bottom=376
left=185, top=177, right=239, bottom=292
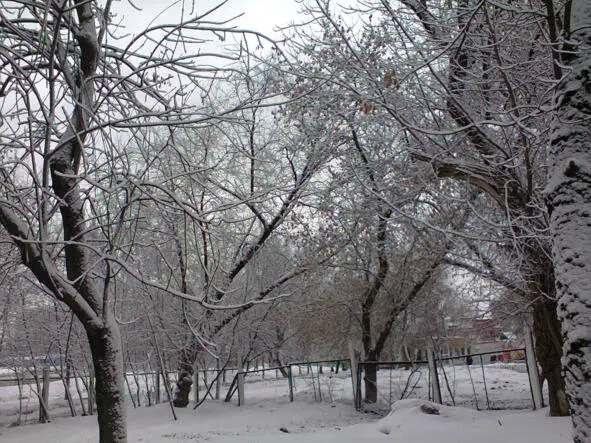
left=0, top=349, right=535, bottom=426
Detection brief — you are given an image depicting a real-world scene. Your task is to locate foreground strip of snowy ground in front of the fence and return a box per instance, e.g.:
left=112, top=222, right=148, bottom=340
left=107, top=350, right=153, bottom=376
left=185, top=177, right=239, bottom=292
left=0, top=399, right=571, bottom=443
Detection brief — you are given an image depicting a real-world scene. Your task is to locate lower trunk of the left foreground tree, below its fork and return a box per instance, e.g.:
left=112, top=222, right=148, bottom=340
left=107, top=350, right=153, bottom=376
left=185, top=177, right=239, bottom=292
left=86, top=320, right=127, bottom=443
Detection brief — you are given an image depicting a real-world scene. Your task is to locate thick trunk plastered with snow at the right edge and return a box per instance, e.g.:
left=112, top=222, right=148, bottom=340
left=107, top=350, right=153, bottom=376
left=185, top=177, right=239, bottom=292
left=546, top=0, right=591, bottom=443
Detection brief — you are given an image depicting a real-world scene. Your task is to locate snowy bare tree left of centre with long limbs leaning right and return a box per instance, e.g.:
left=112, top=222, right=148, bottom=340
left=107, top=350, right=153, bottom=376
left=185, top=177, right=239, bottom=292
left=117, top=57, right=346, bottom=407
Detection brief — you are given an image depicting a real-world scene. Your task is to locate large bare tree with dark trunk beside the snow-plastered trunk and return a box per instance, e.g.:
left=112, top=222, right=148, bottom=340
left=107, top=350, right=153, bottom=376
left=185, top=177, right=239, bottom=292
left=282, top=0, right=570, bottom=415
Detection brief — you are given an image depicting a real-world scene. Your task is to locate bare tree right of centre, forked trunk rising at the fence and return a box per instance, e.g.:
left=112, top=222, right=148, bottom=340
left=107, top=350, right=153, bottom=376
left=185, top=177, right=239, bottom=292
left=284, top=53, right=462, bottom=402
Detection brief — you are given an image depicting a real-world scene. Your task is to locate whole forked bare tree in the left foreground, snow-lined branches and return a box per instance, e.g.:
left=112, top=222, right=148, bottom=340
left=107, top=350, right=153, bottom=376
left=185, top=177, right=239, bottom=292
left=0, top=0, right=288, bottom=443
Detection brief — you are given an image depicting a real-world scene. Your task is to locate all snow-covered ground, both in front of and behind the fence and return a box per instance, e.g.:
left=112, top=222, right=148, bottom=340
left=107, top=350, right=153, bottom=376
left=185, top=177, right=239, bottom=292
left=0, top=368, right=572, bottom=443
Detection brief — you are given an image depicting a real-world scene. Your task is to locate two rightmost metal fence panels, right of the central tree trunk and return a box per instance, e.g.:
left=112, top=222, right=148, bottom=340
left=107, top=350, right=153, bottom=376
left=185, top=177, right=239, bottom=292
left=355, top=348, right=534, bottom=412
